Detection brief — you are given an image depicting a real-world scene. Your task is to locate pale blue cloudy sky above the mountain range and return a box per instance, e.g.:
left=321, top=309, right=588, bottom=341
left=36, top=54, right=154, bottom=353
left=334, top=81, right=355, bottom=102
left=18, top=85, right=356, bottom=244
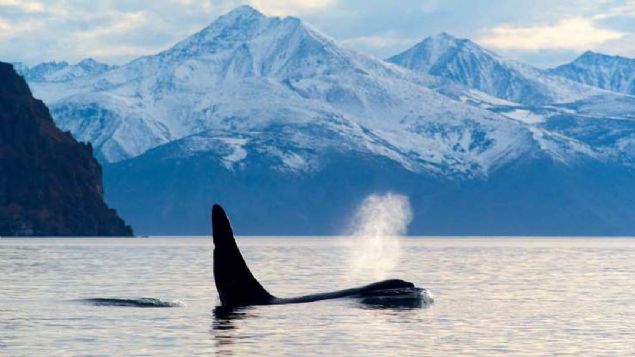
left=0, top=0, right=635, bottom=68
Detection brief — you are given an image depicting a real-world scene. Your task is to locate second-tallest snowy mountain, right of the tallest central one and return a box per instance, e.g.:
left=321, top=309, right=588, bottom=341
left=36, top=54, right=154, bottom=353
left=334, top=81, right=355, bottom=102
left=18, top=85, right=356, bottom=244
left=387, top=33, right=602, bottom=105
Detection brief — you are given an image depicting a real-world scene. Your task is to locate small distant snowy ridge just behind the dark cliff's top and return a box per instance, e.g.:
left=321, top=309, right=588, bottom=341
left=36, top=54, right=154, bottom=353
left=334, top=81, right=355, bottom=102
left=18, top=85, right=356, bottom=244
left=14, top=58, right=116, bottom=82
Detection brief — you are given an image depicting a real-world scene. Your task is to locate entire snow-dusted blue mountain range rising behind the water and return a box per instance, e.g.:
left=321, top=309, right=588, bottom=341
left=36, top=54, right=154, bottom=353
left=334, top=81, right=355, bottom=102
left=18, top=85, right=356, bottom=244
left=16, top=6, right=635, bottom=235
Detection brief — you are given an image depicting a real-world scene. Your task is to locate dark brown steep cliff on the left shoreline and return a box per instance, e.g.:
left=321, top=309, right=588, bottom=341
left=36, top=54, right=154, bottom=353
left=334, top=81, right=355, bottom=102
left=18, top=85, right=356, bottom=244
left=0, top=62, right=132, bottom=236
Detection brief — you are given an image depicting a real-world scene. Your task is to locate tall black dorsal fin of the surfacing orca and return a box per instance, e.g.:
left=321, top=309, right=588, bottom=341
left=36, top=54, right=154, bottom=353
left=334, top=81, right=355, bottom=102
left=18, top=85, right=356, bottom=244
left=212, top=204, right=274, bottom=306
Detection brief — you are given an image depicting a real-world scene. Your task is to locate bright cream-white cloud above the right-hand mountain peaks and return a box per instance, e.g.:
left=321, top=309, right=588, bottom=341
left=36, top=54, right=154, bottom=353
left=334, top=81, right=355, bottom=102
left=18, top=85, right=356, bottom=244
left=477, top=18, right=625, bottom=51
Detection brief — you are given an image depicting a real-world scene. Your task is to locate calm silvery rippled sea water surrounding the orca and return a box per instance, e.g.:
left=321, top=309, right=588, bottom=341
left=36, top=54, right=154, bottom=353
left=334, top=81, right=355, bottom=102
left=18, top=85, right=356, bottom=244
left=0, top=238, right=635, bottom=356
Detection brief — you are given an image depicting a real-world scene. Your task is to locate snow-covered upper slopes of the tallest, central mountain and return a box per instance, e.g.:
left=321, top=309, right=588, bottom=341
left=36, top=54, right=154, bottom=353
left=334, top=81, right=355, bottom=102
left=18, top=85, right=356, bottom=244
left=32, top=6, right=556, bottom=176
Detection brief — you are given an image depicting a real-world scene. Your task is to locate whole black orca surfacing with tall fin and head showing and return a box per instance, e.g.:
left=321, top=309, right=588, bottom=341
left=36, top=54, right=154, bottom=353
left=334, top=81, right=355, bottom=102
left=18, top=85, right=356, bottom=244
left=211, top=204, right=432, bottom=308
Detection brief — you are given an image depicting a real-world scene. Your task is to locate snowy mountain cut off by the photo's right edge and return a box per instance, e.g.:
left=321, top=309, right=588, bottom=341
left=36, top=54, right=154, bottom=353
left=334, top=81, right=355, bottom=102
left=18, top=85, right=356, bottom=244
left=549, top=51, right=635, bottom=94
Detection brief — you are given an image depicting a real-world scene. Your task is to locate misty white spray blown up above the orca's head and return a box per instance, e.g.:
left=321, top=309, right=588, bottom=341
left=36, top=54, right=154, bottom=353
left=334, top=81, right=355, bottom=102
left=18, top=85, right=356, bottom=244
left=350, top=193, right=412, bottom=279
